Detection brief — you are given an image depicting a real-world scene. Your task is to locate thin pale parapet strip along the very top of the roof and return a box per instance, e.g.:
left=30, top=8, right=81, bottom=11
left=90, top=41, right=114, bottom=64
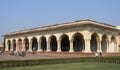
left=3, top=19, right=119, bottom=36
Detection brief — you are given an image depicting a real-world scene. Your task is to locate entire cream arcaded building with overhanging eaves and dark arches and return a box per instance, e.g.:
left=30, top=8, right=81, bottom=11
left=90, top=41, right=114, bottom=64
left=4, top=19, right=120, bottom=53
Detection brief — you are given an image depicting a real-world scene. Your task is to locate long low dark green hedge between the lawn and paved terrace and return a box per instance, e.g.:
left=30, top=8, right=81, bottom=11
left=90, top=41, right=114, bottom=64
left=0, top=57, right=120, bottom=67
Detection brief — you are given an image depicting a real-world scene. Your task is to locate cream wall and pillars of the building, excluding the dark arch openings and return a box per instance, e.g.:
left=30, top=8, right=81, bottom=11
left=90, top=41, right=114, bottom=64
left=5, top=26, right=119, bottom=53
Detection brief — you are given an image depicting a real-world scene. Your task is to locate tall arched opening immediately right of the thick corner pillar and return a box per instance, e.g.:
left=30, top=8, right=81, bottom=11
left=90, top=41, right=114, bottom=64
left=90, top=33, right=99, bottom=52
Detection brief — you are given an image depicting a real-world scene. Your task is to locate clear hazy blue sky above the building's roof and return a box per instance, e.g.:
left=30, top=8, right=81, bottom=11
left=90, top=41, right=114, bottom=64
left=0, top=0, right=120, bottom=41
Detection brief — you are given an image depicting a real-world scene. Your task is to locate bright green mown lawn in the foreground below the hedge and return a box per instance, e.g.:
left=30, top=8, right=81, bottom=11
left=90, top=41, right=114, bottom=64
left=0, top=62, right=120, bottom=70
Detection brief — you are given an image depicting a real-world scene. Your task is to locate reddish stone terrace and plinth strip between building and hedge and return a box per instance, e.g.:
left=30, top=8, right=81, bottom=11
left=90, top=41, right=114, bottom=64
left=0, top=52, right=120, bottom=60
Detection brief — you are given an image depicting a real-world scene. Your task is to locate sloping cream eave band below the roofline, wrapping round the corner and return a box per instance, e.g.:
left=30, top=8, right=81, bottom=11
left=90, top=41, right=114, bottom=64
left=3, top=19, right=120, bottom=37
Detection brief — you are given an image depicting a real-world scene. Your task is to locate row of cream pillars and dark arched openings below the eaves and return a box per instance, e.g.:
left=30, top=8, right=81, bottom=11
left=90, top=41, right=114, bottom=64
left=5, top=32, right=117, bottom=52
